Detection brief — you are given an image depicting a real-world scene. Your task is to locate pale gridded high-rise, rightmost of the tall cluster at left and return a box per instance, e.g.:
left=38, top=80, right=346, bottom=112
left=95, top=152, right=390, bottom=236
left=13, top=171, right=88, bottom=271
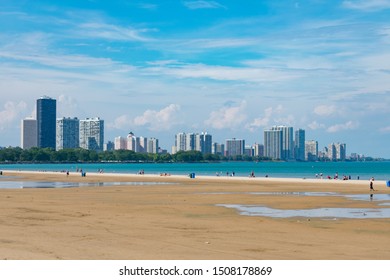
left=79, top=118, right=104, bottom=151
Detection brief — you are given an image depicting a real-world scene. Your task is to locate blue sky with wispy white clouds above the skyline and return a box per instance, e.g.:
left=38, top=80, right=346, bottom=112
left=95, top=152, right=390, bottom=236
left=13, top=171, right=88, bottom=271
left=0, top=0, right=390, bottom=158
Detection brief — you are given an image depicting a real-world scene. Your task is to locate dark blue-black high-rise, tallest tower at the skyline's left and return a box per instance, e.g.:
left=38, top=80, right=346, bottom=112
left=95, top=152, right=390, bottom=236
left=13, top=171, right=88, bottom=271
left=37, top=96, right=57, bottom=149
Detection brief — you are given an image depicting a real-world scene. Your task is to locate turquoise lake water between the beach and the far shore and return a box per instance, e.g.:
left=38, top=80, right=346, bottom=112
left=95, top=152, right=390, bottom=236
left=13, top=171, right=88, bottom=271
left=0, top=161, right=390, bottom=181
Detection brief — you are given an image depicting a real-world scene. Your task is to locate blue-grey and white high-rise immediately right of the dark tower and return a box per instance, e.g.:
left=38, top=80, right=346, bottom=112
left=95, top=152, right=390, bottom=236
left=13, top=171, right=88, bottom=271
left=56, top=118, right=80, bottom=151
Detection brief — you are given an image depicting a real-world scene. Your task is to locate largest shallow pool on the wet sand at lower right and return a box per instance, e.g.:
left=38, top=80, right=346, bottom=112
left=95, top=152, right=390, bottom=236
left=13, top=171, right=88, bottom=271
left=217, top=204, right=390, bottom=219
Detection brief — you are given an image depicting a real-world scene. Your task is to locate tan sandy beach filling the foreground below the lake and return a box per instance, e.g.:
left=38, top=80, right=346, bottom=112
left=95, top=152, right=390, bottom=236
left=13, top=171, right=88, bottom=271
left=0, top=171, right=390, bottom=260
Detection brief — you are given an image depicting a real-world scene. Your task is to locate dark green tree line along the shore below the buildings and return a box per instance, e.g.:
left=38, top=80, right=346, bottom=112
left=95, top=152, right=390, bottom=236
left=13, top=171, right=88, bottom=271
left=0, top=147, right=270, bottom=163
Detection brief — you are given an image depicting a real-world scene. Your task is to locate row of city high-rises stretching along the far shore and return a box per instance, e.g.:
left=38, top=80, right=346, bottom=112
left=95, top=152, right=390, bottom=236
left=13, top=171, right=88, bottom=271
left=20, top=96, right=354, bottom=161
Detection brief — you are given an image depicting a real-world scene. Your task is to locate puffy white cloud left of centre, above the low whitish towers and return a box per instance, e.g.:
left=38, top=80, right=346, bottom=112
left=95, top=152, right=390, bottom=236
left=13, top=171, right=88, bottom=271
left=133, top=104, right=180, bottom=131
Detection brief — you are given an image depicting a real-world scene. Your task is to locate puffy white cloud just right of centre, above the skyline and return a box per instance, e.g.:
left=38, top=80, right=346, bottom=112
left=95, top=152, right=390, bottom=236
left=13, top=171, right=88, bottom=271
left=205, top=101, right=246, bottom=129
